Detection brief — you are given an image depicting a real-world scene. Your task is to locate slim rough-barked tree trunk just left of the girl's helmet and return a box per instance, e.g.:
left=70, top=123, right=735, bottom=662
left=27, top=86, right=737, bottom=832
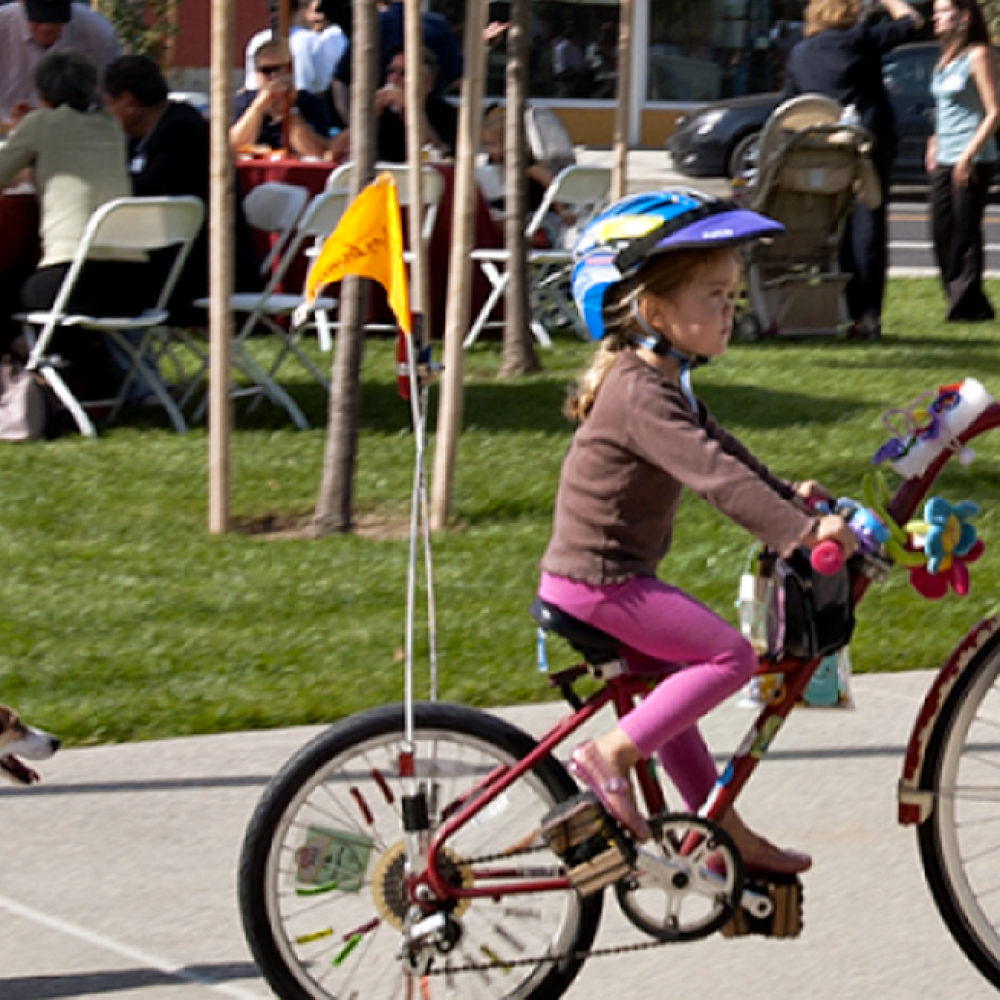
left=500, top=0, right=540, bottom=378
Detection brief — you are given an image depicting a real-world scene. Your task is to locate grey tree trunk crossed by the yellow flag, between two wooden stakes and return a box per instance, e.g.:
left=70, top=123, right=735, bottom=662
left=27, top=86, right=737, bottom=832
left=313, top=3, right=378, bottom=536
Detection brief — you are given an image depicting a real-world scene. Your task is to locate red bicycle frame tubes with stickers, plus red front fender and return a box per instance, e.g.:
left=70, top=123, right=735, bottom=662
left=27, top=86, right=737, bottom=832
left=417, top=403, right=1000, bottom=900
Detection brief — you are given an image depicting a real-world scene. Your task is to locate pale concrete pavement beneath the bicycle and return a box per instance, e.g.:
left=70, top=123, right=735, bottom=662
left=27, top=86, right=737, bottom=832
left=0, top=665, right=996, bottom=1000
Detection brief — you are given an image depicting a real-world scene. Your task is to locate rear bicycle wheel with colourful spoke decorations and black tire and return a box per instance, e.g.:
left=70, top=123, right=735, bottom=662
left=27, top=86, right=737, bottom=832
left=238, top=703, right=602, bottom=1000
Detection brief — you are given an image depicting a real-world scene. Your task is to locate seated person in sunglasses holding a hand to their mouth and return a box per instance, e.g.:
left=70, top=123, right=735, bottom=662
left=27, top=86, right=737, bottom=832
left=229, top=42, right=348, bottom=160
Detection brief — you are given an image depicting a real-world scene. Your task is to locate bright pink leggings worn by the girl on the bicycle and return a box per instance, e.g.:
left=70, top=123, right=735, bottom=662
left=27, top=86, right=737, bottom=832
left=538, top=573, right=757, bottom=811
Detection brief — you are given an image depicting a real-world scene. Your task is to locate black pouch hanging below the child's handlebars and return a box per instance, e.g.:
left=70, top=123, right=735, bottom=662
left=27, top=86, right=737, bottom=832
left=777, top=549, right=854, bottom=660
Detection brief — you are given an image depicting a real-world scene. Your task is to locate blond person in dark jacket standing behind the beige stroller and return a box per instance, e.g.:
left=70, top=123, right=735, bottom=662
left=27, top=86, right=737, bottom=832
left=784, top=0, right=924, bottom=340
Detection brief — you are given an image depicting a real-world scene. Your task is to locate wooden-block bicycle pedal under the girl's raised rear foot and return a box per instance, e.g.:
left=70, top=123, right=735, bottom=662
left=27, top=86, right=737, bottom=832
left=541, top=792, right=635, bottom=896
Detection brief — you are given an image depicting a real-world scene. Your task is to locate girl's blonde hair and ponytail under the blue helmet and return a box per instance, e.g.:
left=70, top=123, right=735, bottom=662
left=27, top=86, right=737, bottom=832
left=563, top=246, right=742, bottom=423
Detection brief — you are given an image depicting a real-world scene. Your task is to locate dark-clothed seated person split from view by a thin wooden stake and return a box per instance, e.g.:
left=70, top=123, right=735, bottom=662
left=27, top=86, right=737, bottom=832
left=375, top=47, right=458, bottom=163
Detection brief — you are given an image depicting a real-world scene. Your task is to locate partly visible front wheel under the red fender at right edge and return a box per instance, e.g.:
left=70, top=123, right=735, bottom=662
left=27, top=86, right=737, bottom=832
left=917, top=635, right=1000, bottom=988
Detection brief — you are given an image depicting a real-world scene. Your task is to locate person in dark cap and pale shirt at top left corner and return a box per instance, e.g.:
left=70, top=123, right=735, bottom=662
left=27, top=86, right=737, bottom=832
left=0, top=0, right=121, bottom=123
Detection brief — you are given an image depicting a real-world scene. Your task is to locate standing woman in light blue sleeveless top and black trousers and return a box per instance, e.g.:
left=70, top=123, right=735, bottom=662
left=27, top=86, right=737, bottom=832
left=926, top=0, right=1000, bottom=323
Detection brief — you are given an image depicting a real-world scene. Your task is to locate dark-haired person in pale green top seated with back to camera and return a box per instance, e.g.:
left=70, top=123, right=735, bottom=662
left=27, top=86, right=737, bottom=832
left=0, top=49, right=152, bottom=368
